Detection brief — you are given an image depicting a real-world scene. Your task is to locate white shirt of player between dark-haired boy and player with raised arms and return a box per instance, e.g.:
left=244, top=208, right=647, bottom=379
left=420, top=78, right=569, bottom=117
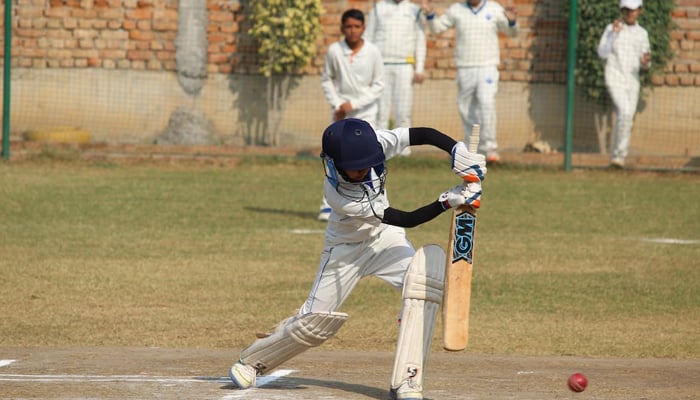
left=365, top=0, right=426, bottom=74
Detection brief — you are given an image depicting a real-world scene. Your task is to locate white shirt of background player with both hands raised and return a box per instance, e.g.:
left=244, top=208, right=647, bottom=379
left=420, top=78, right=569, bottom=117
left=428, top=0, right=518, bottom=67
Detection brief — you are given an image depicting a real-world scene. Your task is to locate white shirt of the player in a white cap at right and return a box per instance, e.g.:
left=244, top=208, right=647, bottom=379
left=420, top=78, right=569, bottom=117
left=598, top=22, right=651, bottom=86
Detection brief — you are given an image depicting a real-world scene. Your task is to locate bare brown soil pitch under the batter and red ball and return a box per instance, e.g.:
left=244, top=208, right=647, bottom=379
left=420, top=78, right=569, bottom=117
left=0, top=347, right=700, bottom=400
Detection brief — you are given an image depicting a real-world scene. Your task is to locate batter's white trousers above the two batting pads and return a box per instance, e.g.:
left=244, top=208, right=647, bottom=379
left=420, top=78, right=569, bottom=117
left=299, top=226, right=415, bottom=315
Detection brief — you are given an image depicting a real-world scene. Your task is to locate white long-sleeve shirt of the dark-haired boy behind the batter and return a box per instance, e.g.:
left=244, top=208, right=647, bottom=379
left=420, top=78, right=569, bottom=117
left=321, top=39, right=384, bottom=112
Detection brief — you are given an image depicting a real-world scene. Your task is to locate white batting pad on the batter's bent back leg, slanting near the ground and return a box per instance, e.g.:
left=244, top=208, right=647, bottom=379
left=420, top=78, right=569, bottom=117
left=241, top=312, right=348, bottom=375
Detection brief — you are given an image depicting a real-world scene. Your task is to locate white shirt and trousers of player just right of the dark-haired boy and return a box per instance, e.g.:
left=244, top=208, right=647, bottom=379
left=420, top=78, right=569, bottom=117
left=365, top=0, right=426, bottom=129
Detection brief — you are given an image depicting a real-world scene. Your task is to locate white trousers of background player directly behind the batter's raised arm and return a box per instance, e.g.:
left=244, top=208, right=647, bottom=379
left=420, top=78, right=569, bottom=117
left=377, top=63, right=414, bottom=129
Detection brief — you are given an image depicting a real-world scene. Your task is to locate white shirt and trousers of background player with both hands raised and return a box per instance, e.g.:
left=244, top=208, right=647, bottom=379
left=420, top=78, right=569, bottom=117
left=428, top=0, right=518, bottom=154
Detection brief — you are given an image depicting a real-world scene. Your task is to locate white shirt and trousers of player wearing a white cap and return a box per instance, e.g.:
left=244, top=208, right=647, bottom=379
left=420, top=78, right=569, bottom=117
left=598, top=23, right=651, bottom=160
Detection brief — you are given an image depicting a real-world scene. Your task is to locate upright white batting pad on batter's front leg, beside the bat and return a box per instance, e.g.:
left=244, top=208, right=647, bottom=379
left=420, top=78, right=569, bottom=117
left=391, top=245, right=446, bottom=391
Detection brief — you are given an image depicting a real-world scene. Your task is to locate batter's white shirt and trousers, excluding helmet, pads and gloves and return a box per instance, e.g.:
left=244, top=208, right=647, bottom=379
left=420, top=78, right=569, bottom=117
left=299, top=128, right=415, bottom=315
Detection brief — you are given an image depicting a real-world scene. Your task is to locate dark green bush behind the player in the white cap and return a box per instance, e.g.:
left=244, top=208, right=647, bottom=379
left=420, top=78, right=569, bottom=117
left=576, top=0, right=674, bottom=102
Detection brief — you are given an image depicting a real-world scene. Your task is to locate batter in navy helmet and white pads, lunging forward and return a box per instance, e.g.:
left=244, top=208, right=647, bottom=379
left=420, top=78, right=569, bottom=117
left=229, top=118, right=486, bottom=400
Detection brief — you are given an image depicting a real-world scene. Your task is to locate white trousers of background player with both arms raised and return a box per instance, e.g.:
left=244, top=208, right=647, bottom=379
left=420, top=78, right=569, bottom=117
left=457, top=65, right=499, bottom=155
